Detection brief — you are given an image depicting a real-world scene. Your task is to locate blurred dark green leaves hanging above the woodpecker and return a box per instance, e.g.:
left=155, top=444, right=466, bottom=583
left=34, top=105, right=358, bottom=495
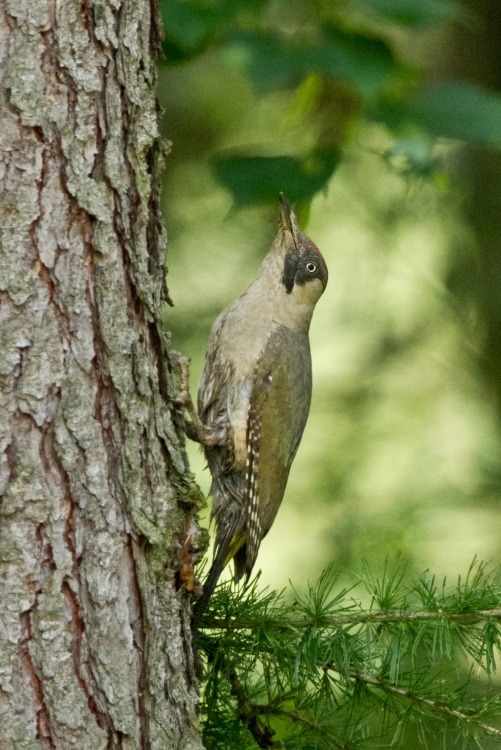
left=161, top=0, right=501, bottom=207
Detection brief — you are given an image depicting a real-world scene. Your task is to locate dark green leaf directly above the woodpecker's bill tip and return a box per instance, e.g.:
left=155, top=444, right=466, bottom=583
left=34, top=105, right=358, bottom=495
left=213, top=149, right=340, bottom=208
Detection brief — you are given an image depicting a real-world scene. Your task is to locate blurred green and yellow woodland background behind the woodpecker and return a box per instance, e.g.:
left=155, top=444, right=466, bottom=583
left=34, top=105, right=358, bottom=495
left=159, top=0, right=501, bottom=589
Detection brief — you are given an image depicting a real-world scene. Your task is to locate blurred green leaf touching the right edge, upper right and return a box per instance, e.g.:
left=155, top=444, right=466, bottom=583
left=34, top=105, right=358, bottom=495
left=371, top=81, right=501, bottom=149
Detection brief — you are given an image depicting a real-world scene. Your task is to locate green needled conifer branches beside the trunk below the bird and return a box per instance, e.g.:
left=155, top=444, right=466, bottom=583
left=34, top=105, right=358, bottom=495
left=199, top=561, right=501, bottom=750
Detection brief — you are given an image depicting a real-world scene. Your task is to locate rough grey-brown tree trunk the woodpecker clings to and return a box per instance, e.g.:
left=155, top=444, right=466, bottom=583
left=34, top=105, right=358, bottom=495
left=0, top=0, right=205, bottom=750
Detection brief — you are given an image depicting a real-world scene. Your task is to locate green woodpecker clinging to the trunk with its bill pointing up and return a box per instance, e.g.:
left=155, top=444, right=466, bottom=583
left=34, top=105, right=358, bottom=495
left=185, top=193, right=328, bottom=629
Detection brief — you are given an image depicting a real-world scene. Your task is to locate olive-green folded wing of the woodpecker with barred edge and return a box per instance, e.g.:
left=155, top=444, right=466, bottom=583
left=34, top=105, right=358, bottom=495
left=245, top=326, right=311, bottom=573
